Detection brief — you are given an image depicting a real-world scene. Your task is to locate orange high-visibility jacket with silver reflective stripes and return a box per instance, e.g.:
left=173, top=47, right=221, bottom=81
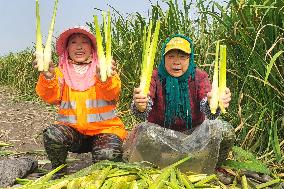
left=36, top=68, right=127, bottom=140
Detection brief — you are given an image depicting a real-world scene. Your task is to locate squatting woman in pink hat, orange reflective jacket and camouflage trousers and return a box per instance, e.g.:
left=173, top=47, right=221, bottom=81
left=33, top=27, right=127, bottom=177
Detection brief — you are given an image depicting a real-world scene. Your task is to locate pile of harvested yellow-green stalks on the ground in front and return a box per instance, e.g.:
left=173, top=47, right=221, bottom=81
left=15, top=157, right=283, bottom=189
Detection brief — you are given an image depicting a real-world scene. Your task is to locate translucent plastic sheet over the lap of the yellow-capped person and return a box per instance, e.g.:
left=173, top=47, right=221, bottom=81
left=124, top=120, right=235, bottom=173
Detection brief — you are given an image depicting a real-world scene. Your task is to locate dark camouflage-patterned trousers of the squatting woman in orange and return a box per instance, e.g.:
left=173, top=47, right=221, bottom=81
left=43, top=125, right=122, bottom=168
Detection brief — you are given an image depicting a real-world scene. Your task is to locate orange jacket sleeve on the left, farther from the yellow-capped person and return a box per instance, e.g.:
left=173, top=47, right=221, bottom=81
left=36, top=70, right=61, bottom=104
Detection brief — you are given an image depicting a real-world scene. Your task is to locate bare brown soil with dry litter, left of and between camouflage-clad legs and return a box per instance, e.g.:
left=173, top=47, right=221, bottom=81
left=0, top=86, right=91, bottom=178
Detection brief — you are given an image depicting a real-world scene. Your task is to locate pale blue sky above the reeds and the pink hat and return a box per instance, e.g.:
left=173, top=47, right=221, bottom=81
left=0, top=0, right=169, bottom=56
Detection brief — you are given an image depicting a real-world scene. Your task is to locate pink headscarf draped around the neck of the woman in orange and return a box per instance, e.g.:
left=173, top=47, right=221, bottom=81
left=59, top=50, right=99, bottom=91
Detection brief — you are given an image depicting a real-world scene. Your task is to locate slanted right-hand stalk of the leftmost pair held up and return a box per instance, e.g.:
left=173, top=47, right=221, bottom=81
left=43, top=0, right=58, bottom=71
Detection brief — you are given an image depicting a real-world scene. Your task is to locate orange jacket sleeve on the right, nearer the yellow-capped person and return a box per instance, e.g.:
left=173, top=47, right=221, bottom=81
left=95, top=74, right=121, bottom=101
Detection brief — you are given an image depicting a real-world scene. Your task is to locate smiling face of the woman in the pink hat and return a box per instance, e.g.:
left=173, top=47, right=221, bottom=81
left=67, top=33, right=92, bottom=63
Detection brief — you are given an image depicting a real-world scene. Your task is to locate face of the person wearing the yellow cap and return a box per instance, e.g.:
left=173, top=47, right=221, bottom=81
left=165, top=49, right=189, bottom=77
